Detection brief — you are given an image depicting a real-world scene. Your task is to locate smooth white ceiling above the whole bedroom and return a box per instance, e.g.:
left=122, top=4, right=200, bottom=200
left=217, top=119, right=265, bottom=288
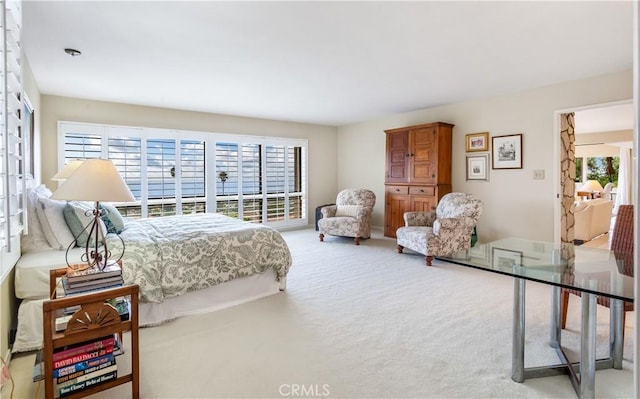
left=23, top=1, right=633, bottom=126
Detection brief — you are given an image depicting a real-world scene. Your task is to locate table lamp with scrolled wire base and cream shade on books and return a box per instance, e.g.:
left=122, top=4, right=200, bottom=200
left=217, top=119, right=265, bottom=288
left=51, top=159, right=135, bottom=270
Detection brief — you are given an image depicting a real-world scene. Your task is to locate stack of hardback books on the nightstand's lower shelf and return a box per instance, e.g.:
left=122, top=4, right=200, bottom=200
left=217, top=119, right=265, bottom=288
left=33, top=334, right=118, bottom=397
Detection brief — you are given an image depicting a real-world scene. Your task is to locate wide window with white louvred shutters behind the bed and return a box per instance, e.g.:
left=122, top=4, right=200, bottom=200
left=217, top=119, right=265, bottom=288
left=59, top=122, right=307, bottom=227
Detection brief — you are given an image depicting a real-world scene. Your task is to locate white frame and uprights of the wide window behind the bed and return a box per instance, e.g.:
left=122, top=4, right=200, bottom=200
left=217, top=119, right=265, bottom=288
left=58, top=121, right=309, bottom=229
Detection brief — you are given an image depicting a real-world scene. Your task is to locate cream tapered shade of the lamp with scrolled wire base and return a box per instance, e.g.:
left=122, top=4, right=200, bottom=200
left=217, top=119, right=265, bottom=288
left=51, top=159, right=135, bottom=202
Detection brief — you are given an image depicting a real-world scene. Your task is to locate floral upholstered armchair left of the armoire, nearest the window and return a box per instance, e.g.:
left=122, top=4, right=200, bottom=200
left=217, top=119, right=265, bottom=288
left=318, top=188, right=376, bottom=245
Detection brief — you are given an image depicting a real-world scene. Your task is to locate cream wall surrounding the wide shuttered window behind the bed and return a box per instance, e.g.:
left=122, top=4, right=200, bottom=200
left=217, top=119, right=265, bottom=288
left=41, top=95, right=338, bottom=223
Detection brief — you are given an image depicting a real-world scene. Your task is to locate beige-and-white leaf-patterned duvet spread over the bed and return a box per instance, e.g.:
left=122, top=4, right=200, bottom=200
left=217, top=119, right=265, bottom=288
left=107, top=213, right=291, bottom=303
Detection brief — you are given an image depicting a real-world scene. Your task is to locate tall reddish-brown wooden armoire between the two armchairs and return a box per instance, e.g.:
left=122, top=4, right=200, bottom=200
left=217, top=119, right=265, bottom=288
left=384, top=122, right=454, bottom=238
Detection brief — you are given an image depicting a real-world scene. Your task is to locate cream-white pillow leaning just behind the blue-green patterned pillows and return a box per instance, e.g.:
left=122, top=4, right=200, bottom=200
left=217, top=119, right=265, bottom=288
left=36, top=198, right=74, bottom=251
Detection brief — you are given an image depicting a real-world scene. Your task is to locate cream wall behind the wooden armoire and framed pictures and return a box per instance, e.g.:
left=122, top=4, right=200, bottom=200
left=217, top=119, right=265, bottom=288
left=338, top=70, right=633, bottom=241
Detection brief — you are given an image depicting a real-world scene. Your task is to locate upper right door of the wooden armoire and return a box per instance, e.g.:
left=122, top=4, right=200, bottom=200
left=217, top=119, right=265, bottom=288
left=409, top=127, right=438, bottom=184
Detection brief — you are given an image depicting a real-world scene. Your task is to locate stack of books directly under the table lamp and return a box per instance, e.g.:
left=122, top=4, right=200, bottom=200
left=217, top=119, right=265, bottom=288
left=62, top=263, right=124, bottom=295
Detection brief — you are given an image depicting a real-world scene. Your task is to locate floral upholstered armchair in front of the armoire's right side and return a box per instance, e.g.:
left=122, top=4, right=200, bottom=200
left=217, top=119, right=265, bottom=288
left=396, top=193, right=483, bottom=266
